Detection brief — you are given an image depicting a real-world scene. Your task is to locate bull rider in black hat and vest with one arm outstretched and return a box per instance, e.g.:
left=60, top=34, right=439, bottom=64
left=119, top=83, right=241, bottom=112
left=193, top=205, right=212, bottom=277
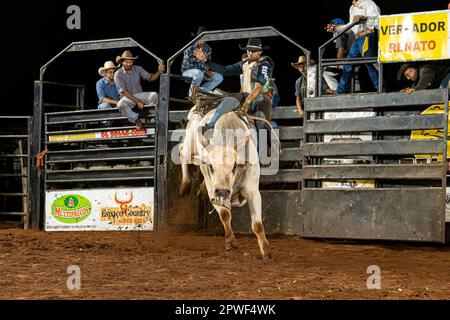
left=194, top=38, right=274, bottom=130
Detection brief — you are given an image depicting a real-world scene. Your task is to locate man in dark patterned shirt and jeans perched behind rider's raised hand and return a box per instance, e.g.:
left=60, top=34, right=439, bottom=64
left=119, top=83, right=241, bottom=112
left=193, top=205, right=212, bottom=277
left=181, top=27, right=223, bottom=96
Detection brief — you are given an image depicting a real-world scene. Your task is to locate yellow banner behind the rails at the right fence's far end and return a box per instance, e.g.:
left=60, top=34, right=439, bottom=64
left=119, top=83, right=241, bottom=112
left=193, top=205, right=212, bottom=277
left=411, top=104, right=450, bottom=163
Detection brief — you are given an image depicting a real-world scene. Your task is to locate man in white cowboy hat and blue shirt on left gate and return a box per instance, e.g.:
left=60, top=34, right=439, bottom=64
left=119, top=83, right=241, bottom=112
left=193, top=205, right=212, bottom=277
left=95, top=61, right=120, bottom=109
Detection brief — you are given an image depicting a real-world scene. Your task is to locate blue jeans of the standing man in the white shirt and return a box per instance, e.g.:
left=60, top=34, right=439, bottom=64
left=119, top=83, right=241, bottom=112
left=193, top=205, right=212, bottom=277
left=336, top=33, right=378, bottom=93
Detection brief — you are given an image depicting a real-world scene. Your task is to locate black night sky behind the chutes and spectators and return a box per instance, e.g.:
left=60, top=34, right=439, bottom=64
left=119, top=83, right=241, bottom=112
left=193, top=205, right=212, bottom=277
left=0, top=0, right=449, bottom=114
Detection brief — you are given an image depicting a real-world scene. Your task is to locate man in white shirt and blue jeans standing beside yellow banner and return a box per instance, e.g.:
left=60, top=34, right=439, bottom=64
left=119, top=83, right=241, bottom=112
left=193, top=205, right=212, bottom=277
left=326, top=0, right=380, bottom=94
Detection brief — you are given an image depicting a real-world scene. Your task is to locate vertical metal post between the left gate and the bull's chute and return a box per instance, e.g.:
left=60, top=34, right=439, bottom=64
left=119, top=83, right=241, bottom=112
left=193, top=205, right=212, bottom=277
left=155, top=73, right=170, bottom=230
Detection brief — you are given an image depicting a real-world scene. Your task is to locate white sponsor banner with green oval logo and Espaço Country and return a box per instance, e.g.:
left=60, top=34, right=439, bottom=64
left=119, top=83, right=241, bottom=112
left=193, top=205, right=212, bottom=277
left=45, top=188, right=154, bottom=231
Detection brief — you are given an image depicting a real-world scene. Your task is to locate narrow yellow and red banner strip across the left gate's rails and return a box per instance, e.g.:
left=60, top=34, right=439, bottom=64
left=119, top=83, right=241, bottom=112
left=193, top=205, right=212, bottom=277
left=48, top=128, right=155, bottom=142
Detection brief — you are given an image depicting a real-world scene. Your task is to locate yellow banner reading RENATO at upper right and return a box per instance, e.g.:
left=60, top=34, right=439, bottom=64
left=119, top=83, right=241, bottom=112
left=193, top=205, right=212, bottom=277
left=378, top=10, right=450, bottom=62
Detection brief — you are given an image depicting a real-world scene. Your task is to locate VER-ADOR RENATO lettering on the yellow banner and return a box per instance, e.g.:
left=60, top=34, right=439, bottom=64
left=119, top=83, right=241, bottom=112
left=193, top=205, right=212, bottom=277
left=380, top=21, right=447, bottom=53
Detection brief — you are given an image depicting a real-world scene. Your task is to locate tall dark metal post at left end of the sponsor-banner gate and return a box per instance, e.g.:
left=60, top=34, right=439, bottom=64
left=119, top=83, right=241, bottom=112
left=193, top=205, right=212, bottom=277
left=29, top=81, right=43, bottom=230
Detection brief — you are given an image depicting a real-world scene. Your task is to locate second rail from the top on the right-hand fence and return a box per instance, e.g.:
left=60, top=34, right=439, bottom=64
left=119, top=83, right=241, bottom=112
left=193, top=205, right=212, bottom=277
left=305, top=114, right=445, bottom=134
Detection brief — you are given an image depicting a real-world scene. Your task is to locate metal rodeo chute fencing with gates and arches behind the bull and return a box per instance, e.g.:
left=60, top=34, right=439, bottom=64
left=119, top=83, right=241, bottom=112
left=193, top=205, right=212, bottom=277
left=0, top=10, right=450, bottom=243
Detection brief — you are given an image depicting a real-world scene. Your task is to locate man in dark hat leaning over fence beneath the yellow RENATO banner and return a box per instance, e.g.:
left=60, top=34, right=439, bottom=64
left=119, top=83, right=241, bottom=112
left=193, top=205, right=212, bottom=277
left=397, top=63, right=450, bottom=94
